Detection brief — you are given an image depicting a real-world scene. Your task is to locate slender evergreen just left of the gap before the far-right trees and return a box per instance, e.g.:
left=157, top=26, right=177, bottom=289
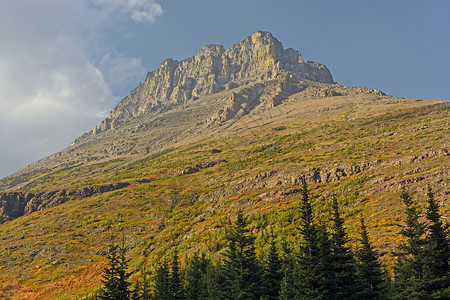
left=356, top=216, right=387, bottom=299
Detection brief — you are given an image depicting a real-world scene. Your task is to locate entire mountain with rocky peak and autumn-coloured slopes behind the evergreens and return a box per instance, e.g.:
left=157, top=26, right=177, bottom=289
left=0, top=31, right=450, bottom=299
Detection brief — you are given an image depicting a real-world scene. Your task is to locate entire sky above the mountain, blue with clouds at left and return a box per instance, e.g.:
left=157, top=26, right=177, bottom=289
left=0, top=0, right=450, bottom=177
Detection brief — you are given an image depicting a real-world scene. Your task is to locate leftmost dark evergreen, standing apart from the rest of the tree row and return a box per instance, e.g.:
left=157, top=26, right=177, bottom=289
left=100, top=244, right=131, bottom=300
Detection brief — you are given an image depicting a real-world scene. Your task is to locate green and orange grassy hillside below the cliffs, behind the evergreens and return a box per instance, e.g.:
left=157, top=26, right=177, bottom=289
left=0, top=96, right=450, bottom=299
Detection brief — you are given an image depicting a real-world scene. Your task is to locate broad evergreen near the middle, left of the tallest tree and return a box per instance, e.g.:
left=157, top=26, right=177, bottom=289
left=223, top=213, right=261, bottom=300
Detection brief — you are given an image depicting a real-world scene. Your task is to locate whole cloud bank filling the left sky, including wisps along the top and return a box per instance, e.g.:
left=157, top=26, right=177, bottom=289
left=0, top=0, right=163, bottom=178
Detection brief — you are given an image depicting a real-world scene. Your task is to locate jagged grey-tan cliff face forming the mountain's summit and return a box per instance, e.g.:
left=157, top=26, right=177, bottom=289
left=93, top=31, right=333, bottom=134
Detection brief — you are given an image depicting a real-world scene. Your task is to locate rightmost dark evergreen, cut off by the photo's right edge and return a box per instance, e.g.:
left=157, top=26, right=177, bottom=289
left=423, top=188, right=450, bottom=299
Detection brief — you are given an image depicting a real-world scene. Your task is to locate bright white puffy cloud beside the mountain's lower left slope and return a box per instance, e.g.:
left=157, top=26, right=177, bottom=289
left=0, top=33, right=114, bottom=175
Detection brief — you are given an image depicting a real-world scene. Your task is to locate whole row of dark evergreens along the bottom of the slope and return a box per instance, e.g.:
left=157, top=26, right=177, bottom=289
left=88, top=179, right=450, bottom=300
